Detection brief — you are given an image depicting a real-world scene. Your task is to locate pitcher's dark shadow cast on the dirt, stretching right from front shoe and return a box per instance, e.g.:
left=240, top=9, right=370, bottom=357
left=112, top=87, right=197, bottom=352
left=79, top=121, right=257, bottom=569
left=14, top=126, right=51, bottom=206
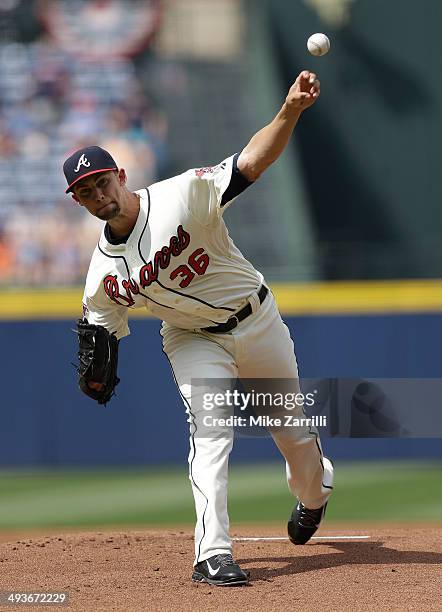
left=237, top=542, right=442, bottom=580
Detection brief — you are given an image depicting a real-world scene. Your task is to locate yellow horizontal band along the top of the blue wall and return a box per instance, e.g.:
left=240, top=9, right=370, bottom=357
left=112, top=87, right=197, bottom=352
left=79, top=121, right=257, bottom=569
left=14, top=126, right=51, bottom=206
left=0, top=280, right=442, bottom=321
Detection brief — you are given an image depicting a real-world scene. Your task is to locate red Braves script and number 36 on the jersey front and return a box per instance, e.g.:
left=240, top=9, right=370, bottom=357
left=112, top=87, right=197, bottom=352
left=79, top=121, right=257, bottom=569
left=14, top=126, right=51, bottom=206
left=103, top=225, right=209, bottom=306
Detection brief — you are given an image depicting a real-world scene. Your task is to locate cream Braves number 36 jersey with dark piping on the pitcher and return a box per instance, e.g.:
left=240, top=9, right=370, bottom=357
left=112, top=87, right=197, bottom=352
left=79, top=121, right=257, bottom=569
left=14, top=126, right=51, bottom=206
left=83, top=156, right=263, bottom=338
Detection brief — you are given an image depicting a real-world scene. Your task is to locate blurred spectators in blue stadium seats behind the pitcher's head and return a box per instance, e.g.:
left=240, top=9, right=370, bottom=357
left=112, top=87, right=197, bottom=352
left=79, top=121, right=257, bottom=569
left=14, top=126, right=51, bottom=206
left=0, top=0, right=167, bottom=285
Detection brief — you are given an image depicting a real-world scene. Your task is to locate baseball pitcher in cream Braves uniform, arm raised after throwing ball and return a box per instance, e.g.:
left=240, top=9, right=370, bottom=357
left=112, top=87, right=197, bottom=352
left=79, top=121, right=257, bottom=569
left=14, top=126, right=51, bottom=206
left=63, top=70, right=333, bottom=585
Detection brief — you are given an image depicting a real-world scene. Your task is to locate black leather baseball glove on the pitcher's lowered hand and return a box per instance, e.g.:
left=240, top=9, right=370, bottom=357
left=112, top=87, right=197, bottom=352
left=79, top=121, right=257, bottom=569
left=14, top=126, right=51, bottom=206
left=77, top=319, right=120, bottom=404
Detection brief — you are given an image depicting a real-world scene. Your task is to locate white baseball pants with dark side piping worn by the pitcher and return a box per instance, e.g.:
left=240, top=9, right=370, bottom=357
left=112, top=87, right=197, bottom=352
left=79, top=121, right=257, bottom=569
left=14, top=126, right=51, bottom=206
left=161, top=292, right=333, bottom=564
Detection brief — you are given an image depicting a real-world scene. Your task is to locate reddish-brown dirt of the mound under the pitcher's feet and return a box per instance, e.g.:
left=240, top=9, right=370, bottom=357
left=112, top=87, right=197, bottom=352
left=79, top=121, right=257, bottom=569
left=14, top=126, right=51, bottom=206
left=0, top=524, right=442, bottom=612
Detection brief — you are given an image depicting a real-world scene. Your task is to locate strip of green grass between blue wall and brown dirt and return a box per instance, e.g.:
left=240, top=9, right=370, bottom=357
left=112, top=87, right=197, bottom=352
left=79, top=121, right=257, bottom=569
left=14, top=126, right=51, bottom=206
left=0, top=462, right=442, bottom=530
